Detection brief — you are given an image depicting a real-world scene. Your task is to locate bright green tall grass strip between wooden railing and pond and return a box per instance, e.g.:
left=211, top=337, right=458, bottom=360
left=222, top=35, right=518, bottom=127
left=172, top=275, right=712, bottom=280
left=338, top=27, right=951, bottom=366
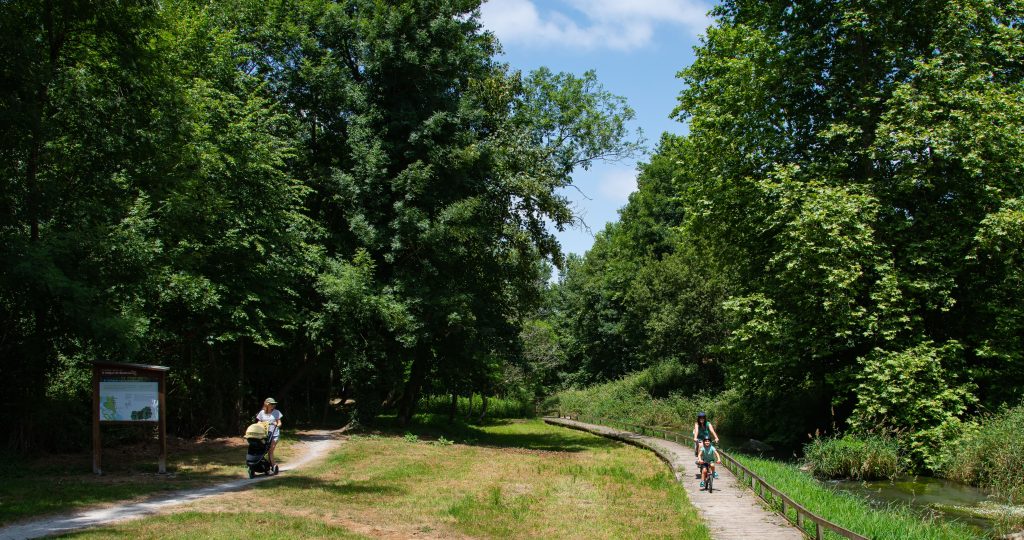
left=731, top=454, right=985, bottom=540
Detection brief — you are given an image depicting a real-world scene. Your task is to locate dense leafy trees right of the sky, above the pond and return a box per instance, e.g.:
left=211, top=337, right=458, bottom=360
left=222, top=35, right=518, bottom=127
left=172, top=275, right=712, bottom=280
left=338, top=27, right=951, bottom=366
left=541, top=0, right=1024, bottom=468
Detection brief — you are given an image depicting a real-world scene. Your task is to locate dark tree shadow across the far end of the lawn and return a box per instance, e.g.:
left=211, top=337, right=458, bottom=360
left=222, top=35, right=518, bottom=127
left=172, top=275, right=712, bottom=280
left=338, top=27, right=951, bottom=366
left=374, top=414, right=621, bottom=452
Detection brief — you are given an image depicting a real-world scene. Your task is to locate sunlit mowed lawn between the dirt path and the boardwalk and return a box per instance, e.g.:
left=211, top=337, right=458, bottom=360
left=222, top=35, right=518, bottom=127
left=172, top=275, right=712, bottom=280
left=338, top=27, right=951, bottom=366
left=61, top=417, right=709, bottom=539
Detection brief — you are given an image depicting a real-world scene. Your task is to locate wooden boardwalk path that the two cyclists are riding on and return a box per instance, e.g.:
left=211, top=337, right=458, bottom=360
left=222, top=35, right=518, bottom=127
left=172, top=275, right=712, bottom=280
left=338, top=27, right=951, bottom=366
left=544, top=418, right=804, bottom=540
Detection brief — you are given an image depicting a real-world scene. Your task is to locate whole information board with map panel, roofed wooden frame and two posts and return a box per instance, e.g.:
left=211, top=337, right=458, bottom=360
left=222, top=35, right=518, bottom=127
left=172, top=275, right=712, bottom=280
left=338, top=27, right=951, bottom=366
left=92, top=362, right=170, bottom=474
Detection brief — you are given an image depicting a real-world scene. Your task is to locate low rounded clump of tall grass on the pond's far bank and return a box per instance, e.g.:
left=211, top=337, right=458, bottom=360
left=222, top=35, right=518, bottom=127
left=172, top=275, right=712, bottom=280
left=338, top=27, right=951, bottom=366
left=804, top=433, right=902, bottom=480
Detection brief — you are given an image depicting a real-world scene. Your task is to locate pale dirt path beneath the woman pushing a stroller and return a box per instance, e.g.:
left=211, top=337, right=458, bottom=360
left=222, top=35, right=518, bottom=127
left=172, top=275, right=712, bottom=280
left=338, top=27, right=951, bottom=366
left=0, top=429, right=342, bottom=540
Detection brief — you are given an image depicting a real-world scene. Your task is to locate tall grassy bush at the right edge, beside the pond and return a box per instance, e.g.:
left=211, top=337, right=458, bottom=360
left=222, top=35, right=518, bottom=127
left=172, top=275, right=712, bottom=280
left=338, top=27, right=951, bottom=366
left=941, top=404, right=1024, bottom=504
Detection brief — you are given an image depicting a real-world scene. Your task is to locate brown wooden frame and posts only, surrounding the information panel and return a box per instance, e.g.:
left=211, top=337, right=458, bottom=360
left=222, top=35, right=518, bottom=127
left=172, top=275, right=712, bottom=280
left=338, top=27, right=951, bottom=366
left=92, top=361, right=170, bottom=474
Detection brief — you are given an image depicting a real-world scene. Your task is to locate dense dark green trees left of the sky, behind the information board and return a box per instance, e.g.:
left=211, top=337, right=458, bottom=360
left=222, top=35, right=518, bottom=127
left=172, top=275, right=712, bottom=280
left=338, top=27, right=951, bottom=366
left=0, top=0, right=636, bottom=449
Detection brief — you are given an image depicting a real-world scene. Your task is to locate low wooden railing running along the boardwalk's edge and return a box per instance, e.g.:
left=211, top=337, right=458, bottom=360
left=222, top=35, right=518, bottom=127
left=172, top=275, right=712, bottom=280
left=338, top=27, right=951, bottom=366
left=549, top=411, right=868, bottom=540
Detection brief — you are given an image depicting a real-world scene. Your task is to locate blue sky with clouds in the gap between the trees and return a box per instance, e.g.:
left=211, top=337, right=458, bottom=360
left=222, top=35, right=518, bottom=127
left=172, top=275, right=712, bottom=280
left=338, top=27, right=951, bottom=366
left=481, top=0, right=712, bottom=254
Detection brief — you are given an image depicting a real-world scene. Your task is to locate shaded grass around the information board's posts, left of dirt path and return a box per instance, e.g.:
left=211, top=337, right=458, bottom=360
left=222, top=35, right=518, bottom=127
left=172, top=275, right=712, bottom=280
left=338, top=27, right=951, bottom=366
left=0, top=431, right=294, bottom=525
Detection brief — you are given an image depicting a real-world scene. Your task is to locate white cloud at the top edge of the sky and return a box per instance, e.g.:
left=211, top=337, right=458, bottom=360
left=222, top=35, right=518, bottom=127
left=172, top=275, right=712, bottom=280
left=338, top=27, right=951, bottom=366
left=480, top=0, right=711, bottom=50
